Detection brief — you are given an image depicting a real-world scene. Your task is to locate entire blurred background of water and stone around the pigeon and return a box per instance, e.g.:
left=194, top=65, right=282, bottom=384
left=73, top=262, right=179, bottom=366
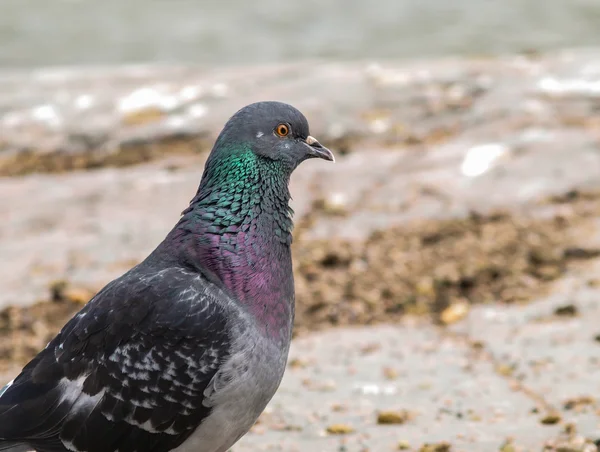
left=0, top=0, right=600, bottom=452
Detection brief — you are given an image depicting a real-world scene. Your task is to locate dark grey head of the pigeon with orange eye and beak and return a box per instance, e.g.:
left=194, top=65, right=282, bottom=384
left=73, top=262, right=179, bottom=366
left=215, top=102, right=335, bottom=171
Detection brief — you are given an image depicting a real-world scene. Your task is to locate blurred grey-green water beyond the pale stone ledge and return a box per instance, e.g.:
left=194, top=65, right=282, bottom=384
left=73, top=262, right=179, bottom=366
left=0, top=0, right=600, bottom=68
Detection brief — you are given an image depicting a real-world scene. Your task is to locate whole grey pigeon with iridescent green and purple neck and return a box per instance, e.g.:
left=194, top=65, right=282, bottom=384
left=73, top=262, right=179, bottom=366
left=0, top=102, right=335, bottom=452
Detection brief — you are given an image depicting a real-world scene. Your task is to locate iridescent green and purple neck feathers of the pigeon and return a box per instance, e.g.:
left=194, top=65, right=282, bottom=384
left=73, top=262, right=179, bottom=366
left=172, top=150, right=294, bottom=339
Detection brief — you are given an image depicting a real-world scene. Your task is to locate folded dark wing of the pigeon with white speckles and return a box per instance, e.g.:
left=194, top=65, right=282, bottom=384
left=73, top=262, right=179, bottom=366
left=0, top=266, right=230, bottom=452
